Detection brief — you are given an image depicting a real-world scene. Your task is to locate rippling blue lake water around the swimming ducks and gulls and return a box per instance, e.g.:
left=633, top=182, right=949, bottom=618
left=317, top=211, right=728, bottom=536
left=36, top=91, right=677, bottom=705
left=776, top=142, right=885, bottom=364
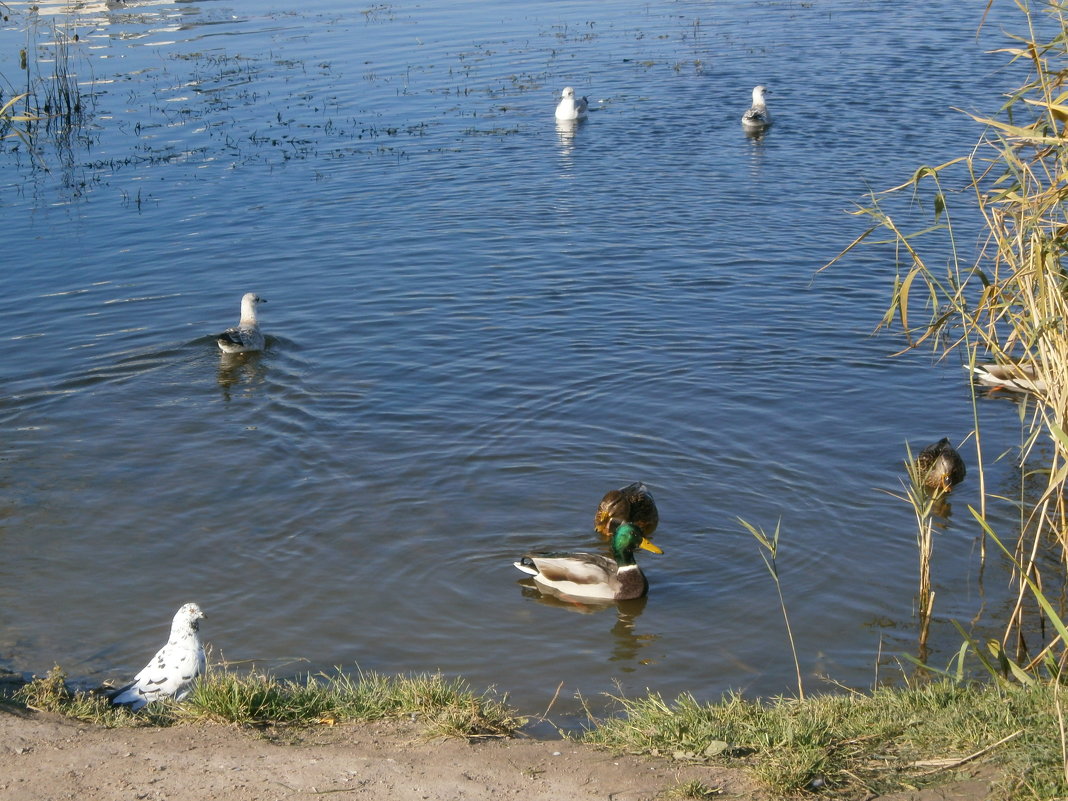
left=0, top=0, right=1042, bottom=724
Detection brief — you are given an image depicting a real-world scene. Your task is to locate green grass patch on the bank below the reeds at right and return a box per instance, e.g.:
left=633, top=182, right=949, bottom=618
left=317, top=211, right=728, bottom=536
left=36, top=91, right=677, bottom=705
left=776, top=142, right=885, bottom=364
left=583, top=681, right=1068, bottom=799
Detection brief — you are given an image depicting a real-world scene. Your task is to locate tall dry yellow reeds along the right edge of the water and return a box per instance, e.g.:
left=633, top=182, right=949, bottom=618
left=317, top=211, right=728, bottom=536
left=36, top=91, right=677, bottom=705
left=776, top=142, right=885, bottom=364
left=832, top=3, right=1068, bottom=679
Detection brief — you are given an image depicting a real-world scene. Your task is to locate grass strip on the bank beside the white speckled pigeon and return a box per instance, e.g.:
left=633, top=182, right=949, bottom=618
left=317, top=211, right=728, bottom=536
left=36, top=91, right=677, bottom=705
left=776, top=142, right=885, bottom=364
left=14, top=666, right=525, bottom=738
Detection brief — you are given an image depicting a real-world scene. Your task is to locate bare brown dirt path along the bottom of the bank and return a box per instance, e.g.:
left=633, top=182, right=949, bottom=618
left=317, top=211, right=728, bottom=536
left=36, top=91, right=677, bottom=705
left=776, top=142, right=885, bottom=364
left=0, top=707, right=764, bottom=801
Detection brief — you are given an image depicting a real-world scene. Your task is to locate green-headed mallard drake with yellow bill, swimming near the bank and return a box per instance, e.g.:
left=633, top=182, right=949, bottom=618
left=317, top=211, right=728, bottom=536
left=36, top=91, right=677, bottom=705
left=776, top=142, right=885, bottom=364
left=513, top=523, right=663, bottom=600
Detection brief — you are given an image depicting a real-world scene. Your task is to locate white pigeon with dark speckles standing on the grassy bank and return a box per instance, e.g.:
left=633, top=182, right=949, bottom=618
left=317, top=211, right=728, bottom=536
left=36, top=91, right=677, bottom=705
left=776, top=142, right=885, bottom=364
left=110, top=603, right=205, bottom=712
